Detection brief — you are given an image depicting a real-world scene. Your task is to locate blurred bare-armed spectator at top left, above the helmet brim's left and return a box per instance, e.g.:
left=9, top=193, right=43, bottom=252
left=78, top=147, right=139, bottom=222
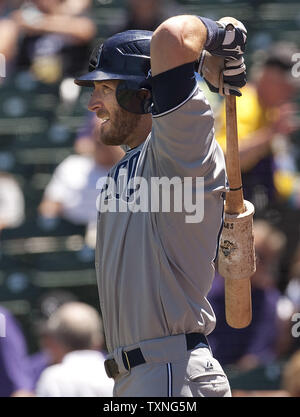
left=11, top=0, right=96, bottom=83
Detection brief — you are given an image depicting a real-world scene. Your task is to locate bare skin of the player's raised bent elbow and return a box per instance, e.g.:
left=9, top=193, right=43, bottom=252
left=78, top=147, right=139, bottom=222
left=151, top=15, right=206, bottom=70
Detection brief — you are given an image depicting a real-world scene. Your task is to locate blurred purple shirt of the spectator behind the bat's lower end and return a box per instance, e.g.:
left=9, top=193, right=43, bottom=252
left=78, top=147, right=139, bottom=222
left=209, top=275, right=279, bottom=368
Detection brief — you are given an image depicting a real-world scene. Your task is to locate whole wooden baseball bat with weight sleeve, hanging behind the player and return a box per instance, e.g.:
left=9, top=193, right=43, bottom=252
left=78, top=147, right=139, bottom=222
left=219, top=96, right=255, bottom=328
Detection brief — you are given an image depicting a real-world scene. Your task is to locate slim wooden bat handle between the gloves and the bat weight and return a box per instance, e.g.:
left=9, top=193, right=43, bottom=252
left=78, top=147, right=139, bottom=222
left=225, top=95, right=245, bottom=214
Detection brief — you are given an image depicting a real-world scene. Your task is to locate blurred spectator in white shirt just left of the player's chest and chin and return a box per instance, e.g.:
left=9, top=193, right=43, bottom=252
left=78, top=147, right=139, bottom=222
left=39, top=115, right=124, bottom=244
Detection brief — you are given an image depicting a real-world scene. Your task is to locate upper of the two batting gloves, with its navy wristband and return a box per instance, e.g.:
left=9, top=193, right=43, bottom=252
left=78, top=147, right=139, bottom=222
left=199, top=17, right=247, bottom=59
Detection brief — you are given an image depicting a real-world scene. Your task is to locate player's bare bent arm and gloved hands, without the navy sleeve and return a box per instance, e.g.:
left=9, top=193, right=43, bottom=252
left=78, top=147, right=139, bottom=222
left=151, top=15, right=247, bottom=96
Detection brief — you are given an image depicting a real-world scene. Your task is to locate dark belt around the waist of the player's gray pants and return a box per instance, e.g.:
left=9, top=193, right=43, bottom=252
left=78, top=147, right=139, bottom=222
left=104, top=333, right=209, bottom=378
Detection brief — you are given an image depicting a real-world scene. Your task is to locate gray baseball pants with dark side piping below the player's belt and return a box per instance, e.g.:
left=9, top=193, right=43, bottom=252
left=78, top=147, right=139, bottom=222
left=105, top=334, right=231, bottom=397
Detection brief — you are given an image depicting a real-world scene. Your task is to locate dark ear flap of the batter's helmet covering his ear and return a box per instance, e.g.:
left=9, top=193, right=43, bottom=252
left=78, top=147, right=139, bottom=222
left=116, top=80, right=152, bottom=114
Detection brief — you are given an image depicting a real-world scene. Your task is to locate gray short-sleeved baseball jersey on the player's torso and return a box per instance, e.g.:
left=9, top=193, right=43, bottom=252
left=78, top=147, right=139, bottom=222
left=96, top=86, right=226, bottom=352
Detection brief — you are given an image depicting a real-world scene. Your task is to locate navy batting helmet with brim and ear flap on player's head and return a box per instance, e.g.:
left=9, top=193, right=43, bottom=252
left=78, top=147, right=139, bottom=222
left=75, top=30, right=153, bottom=114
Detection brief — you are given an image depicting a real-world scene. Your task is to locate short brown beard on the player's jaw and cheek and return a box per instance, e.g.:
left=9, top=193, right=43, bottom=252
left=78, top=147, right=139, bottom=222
left=100, top=107, right=142, bottom=146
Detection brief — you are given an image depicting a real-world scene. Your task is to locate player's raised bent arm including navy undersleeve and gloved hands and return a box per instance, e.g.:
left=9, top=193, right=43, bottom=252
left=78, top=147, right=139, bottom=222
left=150, top=15, right=247, bottom=121
